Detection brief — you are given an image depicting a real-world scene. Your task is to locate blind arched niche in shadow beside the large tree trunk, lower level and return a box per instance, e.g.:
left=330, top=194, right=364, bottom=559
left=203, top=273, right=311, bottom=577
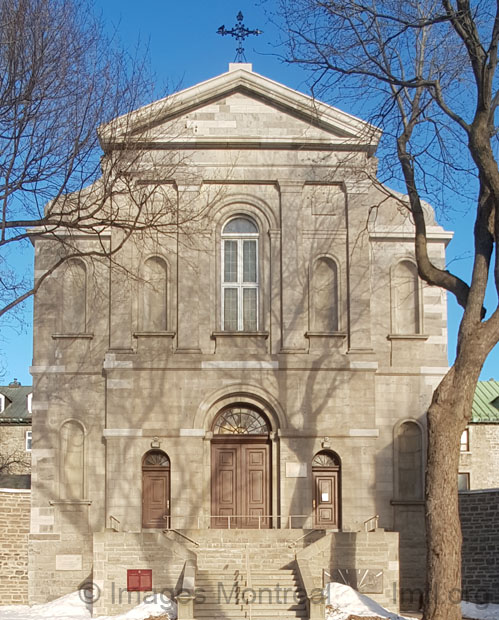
left=395, top=420, right=423, bottom=500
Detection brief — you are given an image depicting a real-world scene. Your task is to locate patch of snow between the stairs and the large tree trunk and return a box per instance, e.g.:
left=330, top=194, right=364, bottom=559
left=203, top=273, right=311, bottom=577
left=326, top=582, right=413, bottom=620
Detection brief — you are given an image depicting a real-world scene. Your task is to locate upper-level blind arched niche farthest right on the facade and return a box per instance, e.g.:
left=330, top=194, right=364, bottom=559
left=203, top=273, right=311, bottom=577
left=392, top=260, right=421, bottom=334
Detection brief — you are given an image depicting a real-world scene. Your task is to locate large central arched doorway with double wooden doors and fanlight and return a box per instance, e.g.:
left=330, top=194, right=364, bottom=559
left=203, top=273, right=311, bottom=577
left=211, top=405, right=271, bottom=528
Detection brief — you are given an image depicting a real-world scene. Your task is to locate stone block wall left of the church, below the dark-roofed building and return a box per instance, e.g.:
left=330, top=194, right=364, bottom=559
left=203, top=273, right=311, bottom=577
left=0, top=489, right=31, bottom=605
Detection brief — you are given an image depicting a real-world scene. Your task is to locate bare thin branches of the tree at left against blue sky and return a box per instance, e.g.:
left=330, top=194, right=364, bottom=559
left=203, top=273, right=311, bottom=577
left=0, top=0, right=193, bottom=330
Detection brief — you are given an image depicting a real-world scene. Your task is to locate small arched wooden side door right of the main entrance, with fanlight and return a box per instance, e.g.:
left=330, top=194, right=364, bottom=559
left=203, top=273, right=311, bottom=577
left=312, top=450, right=341, bottom=529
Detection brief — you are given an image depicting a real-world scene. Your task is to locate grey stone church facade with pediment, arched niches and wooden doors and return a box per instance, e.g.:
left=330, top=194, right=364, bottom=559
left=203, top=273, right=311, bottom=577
left=29, top=64, right=450, bottom=612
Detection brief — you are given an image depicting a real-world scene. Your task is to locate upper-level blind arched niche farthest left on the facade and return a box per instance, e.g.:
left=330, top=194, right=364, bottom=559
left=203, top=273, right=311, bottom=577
left=62, top=259, right=88, bottom=334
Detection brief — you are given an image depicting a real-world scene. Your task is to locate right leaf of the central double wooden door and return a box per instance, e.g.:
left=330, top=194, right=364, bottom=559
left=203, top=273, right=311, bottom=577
left=241, top=444, right=270, bottom=528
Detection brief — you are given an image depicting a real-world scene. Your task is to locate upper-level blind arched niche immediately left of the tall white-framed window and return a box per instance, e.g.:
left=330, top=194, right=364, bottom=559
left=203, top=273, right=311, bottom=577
left=140, top=256, right=168, bottom=332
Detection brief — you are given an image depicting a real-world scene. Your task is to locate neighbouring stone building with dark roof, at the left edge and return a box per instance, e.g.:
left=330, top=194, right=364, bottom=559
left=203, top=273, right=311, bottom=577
left=0, top=379, right=32, bottom=489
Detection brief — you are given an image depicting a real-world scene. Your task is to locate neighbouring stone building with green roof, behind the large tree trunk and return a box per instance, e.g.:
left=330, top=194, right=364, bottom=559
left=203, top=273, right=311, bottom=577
left=459, top=379, right=499, bottom=491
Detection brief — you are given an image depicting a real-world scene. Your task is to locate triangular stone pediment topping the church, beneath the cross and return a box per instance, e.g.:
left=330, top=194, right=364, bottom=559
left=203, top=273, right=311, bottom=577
left=99, top=64, right=380, bottom=151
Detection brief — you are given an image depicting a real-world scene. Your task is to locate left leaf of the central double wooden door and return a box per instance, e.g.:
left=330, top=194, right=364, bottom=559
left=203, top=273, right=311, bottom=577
left=211, top=444, right=241, bottom=528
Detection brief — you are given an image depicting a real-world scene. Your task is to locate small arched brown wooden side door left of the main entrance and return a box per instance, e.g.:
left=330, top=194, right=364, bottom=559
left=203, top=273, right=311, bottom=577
left=142, top=450, right=170, bottom=528
